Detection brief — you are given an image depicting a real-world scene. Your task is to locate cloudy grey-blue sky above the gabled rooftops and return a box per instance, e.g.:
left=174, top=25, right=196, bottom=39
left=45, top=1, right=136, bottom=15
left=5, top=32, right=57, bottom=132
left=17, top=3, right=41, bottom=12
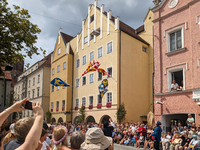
left=7, top=0, right=154, bottom=65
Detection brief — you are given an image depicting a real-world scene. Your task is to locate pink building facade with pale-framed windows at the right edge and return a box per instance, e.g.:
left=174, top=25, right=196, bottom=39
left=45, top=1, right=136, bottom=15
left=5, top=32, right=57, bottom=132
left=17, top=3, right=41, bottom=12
left=152, top=0, right=200, bottom=132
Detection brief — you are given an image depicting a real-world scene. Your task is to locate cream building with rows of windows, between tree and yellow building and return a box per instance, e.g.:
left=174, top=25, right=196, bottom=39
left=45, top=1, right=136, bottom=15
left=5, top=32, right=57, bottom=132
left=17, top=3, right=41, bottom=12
left=14, top=54, right=51, bottom=119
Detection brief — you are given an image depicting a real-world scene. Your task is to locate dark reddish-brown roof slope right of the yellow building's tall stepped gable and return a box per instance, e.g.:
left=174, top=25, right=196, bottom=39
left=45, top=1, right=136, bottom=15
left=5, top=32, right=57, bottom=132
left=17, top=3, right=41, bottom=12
left=120, top=21, right=149, bottom=45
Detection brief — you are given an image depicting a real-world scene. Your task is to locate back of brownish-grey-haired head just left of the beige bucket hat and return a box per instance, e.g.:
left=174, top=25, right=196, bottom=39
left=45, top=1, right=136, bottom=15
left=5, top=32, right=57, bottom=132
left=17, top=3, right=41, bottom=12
left=70, top=131, right=85, bottom=150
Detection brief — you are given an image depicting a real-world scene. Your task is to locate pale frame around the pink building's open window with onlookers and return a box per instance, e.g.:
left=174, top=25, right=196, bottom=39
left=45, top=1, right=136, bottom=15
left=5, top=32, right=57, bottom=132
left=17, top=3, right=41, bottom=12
left=168, top=67, right=185, bottom=92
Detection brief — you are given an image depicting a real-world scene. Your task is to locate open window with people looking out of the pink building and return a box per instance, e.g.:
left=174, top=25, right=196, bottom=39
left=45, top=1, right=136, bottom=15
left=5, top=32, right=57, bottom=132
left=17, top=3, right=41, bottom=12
left=168, top=68, right=185, bottom=91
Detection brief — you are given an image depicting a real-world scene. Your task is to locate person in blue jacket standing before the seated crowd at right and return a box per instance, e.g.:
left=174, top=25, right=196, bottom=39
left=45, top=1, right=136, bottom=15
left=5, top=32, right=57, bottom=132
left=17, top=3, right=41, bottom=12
left=151, top=121, right=161, bottom=150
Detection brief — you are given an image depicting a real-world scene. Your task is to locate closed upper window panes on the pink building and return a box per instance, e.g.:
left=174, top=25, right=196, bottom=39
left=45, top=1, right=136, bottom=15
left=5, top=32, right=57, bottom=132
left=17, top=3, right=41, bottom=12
left=168, top=29, right=183, bottom=51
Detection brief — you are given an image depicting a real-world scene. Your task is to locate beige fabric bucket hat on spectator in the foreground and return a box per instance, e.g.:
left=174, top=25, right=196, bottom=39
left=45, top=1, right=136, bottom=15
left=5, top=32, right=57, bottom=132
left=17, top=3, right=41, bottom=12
left=81, top=127, right=112, bottom=150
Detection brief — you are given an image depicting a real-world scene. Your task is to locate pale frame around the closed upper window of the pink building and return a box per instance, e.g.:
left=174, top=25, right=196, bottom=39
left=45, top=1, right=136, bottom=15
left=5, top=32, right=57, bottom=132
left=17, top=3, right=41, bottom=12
left=167, top=27, right=184, bottom=53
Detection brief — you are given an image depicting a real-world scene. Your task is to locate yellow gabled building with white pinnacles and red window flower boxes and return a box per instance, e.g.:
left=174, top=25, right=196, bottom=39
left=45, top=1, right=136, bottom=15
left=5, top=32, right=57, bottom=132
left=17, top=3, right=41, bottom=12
left=51, top=0, right=152, bottom=123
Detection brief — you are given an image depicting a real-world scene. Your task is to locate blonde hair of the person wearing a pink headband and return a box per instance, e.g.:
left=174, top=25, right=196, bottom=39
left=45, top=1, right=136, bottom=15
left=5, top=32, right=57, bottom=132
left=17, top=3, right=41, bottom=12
left=53, top=127, right=68, bottom=150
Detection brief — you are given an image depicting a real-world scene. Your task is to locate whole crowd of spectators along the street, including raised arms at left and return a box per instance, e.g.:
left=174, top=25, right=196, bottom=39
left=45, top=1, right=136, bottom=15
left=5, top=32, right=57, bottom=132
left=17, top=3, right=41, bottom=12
left=0, top=99, right=200, bottom=150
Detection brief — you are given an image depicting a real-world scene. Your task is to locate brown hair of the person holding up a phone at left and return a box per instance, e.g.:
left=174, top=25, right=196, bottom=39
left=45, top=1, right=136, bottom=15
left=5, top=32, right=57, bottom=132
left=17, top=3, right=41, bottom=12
left=14, top=117, right=34, bottom=142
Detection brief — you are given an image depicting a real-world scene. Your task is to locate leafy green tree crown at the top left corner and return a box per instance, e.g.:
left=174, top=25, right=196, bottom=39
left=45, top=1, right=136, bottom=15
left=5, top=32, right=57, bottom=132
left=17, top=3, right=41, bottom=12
left=0, top=0, right=46, bottom=70
